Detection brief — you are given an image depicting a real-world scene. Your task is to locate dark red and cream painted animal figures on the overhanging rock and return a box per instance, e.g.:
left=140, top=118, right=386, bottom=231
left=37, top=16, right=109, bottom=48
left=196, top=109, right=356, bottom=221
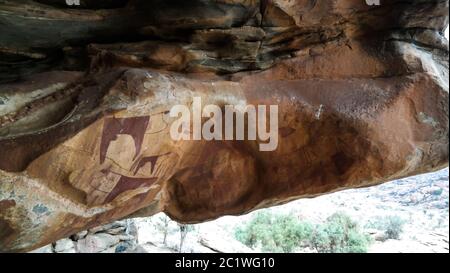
left=80, top=113, right=171, bottom=205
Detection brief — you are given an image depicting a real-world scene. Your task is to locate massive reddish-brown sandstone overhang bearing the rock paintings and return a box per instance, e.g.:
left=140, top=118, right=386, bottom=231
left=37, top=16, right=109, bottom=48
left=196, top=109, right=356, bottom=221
left=0, top=0, right=449, bottom=252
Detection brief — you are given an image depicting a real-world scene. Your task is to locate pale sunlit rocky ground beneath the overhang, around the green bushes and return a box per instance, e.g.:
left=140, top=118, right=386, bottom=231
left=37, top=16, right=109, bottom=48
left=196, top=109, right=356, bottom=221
left=29, top=169, right=449, bottom=253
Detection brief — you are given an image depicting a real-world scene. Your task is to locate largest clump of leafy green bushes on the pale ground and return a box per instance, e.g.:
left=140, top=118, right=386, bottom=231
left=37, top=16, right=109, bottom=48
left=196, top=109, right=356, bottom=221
left=235, top=212, right=370, bottom=253
